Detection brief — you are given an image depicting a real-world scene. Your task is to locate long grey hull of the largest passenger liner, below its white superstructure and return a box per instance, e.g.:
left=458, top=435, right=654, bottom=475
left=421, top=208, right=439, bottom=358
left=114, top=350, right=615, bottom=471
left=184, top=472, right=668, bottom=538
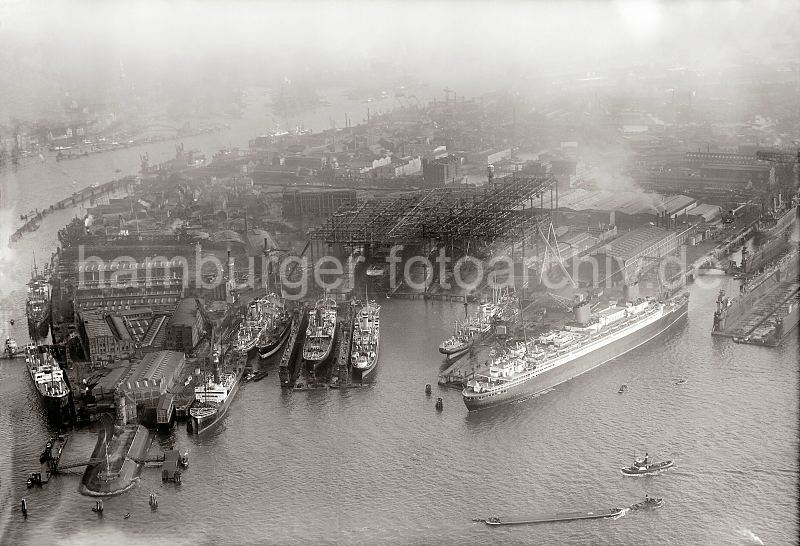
left=462, top=298, right=689, bottom=411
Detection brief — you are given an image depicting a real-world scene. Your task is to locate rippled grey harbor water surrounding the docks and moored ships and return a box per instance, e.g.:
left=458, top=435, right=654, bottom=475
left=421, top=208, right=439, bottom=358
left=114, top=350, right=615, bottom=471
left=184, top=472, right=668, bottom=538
left=0, top=101, right=798, bottom=544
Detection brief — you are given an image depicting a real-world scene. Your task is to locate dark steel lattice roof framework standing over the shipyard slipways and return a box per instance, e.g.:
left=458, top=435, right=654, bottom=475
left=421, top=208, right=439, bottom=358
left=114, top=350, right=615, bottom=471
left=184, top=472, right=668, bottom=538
left=309, top=176, right=558, bottom=245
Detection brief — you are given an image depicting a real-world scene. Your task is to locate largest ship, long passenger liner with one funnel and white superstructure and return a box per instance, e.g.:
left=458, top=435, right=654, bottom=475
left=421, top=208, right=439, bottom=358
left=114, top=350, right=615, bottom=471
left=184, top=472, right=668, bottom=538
left=462, top=294, right=689, bottom=411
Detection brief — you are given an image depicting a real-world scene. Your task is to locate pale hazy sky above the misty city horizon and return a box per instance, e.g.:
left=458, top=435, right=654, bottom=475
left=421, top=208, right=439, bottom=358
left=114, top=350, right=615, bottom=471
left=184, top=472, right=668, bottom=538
left=0, top=0, right=800, bottom=119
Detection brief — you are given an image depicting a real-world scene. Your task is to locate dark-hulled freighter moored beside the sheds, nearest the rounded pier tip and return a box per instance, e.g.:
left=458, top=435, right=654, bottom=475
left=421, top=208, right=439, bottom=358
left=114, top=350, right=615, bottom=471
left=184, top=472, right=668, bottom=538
left=188, top=347, right=244, bottom=434
